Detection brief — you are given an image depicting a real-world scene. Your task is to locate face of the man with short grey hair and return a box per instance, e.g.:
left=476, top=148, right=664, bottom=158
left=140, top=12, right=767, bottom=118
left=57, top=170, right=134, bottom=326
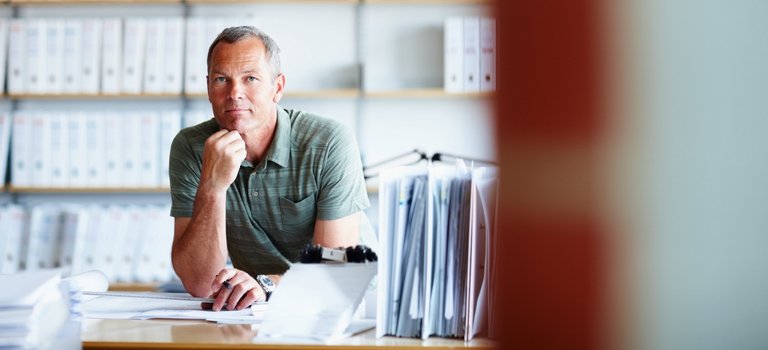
left=208, top=38, right=283, bottom=134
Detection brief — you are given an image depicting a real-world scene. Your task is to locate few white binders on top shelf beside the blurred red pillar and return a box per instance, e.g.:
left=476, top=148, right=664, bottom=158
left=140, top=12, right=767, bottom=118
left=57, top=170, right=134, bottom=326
left=443, top=17, right=496, bottom=93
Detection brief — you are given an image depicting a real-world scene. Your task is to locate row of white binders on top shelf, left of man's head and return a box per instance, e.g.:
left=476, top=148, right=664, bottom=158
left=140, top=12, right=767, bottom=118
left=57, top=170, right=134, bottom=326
left=0, top=16, right=254, bottom=95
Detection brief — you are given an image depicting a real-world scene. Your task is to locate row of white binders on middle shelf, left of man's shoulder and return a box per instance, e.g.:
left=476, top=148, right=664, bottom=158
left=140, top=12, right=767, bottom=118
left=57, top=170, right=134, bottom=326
left=10, top=110, right=182, bottom=188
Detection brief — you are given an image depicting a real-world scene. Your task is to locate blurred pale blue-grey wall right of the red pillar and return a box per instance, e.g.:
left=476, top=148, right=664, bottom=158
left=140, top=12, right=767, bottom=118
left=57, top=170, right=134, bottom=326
left=612, top=0, right=768, bottom=350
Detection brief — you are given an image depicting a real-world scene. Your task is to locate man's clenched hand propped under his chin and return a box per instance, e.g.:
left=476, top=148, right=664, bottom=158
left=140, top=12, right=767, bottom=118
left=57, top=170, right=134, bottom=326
left=200, top=129, right=246, bottom=192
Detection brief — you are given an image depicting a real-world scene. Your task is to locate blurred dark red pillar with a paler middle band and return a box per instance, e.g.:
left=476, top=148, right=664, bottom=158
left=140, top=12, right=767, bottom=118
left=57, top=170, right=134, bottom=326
left=493, top=0, right=607, bottom=349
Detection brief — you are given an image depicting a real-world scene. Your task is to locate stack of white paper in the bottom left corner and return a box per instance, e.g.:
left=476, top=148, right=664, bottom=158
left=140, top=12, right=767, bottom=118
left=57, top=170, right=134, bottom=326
left=0, top=270, right=69, bottom=349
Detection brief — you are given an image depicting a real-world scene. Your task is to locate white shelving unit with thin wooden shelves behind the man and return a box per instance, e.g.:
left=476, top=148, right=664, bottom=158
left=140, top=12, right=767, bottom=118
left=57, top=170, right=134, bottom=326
left=0, top=0, right=495, bottom=288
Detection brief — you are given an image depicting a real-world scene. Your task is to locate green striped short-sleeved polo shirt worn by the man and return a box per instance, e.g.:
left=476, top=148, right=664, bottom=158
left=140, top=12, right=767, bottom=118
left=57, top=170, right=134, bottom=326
left=169, top=106, right=370, bottom=275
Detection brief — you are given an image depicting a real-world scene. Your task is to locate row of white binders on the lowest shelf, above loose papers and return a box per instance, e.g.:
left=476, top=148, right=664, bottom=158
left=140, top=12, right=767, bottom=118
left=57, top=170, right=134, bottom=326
left=0, top=203, right=173, bottom=283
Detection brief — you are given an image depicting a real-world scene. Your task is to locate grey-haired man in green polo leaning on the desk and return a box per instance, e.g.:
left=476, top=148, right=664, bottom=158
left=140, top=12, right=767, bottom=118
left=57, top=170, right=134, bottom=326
left=170, top=26, right=370, bottom=311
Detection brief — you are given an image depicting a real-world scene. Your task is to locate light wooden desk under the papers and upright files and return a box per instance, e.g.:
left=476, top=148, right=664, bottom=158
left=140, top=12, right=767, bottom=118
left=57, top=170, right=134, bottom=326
left=81, top=319, right=494, bottom=350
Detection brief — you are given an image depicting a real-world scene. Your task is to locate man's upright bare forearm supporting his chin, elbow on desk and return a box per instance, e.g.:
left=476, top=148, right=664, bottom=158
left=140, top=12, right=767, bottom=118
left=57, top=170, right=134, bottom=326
left=172, top=187, right=227, bottom=297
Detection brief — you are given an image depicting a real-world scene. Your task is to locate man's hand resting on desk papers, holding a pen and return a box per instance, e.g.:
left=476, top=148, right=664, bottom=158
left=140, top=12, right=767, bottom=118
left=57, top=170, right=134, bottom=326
left=211, top=269, right=267, bottom=311
